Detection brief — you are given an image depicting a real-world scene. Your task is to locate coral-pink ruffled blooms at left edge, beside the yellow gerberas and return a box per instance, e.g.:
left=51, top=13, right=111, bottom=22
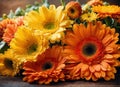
left=0, top=17, right=23, bottom=44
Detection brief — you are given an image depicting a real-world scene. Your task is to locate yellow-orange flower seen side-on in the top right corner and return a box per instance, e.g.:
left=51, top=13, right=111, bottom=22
left=92, top=5, right=120, bottom=19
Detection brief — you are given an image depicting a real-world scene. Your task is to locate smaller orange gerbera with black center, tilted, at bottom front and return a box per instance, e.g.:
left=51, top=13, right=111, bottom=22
left=23, top=46, right=65, bottom=84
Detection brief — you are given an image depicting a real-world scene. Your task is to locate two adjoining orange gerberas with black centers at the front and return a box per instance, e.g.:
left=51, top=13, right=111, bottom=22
left=23, top=22, right=120, bottom=84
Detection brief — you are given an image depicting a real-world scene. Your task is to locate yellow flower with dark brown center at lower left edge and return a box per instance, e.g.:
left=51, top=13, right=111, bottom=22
left=0, top=49, right=21, bottom=76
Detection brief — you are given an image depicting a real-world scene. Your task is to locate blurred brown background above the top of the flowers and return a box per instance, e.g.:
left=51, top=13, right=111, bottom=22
left=0, top=0, right=120, bottom=17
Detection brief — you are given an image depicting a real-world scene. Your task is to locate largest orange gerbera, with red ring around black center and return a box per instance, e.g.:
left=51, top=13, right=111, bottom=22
left=64, top=22, right=120, bottom=81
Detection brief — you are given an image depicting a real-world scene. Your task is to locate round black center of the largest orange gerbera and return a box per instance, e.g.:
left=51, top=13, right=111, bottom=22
left=82, top=43, right=97, bottom=56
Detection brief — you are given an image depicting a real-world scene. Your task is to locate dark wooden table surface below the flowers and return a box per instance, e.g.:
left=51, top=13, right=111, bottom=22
left=0, top=72, right=120, bottom=87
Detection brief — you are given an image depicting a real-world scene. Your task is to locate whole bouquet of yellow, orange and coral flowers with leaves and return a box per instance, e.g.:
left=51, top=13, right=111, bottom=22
left=0, top=0, right=120, bottom=84
